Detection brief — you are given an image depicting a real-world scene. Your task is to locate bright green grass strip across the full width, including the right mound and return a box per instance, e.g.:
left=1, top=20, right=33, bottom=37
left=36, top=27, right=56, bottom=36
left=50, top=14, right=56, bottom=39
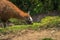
left=0, top=16, right=60, bottom=33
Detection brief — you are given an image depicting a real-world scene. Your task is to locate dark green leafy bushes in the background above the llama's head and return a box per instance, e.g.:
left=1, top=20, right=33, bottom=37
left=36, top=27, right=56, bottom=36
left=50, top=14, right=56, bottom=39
left=10, top=0, right=60, bottom=15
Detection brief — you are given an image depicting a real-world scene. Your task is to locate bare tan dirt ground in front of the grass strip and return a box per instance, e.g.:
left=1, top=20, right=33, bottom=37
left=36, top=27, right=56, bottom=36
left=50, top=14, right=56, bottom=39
left=0, top=29, right=60, bottom=40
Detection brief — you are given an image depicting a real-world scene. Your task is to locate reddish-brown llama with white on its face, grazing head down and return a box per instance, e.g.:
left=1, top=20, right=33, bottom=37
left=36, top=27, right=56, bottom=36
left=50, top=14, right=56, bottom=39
left=0, top=0, right=33, bottom=27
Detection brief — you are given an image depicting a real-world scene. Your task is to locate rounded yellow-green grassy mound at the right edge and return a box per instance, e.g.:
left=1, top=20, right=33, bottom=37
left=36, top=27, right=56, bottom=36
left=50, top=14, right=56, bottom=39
left=41, top=16, right=60, bottom=27
